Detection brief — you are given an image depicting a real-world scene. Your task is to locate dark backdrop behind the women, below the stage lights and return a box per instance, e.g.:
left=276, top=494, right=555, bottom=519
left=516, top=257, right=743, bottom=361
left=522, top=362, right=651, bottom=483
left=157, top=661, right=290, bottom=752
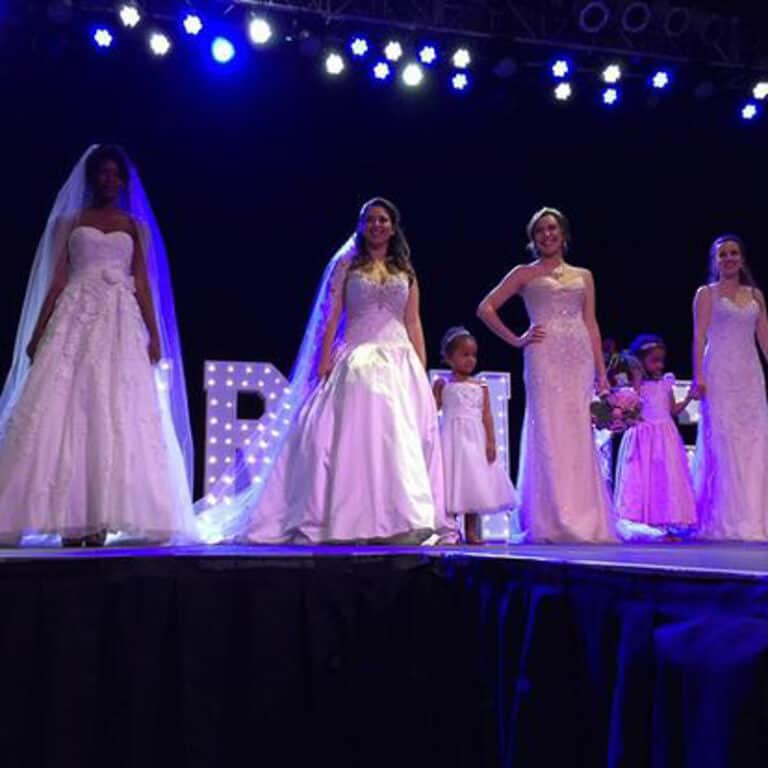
left=0, top=4, right=768, bottom=492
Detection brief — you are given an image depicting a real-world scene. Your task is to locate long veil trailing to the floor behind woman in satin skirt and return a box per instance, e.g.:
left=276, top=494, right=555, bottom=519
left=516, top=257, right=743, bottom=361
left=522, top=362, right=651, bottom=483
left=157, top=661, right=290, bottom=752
left=195, top=234, right=356, bottom=542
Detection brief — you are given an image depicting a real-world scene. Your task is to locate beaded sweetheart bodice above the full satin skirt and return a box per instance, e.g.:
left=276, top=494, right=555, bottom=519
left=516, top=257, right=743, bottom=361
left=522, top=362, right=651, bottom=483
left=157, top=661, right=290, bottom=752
left=344, top=270, right=410, bottom=344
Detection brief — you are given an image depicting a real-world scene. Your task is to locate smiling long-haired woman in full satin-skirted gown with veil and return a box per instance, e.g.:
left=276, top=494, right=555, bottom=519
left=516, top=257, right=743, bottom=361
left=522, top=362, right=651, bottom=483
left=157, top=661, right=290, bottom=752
left=235, top=198, right=453, bottom=543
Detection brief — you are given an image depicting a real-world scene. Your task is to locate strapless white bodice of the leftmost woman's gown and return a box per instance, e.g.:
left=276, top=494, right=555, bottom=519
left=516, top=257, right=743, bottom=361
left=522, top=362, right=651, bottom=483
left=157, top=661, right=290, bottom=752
left=69, top=225, right=133, bottom=287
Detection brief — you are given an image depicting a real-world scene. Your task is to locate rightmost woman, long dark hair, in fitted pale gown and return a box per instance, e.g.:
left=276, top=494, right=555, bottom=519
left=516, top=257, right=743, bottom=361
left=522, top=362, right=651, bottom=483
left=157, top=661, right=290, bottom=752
left=693, top=235, right=768, bottom=541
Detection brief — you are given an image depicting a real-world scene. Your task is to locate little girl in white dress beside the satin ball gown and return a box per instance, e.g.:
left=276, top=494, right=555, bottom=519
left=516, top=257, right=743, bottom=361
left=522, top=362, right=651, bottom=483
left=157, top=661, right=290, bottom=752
left=433, top=327, right=517, bottom=544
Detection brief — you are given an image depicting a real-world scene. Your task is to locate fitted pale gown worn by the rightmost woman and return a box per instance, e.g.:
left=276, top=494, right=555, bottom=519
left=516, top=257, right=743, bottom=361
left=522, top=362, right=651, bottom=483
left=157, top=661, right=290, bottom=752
left=694, top=289, right=768, bottom=541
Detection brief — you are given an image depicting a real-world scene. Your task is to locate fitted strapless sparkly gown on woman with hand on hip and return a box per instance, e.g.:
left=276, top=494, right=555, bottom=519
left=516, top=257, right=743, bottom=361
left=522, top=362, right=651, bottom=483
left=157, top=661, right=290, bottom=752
left=517, top=275, right=615, bottom=542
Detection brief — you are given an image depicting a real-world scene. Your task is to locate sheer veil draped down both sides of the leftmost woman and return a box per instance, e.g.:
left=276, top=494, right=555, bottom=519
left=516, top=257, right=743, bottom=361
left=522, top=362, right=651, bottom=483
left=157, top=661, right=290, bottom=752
left=0, top=145, right=194, bottom=494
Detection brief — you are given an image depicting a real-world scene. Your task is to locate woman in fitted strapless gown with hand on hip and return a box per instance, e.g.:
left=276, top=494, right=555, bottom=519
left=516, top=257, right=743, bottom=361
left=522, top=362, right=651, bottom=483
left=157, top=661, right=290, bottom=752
left=478, top=208, right=615, bottom=542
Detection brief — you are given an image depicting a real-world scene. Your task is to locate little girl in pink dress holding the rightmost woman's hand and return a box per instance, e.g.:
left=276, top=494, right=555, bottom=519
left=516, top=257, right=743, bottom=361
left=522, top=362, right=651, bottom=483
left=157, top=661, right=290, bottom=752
left=614, top=334, right=696, bottom=534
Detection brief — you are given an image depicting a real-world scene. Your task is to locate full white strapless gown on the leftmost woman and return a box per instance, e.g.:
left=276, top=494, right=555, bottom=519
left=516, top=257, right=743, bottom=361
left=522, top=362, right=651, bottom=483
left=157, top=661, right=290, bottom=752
left=0, top=225, right=194, bottom=540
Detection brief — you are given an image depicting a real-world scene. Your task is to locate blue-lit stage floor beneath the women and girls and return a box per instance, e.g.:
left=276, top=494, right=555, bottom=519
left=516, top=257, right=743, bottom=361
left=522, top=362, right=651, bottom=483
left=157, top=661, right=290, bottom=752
left=0, top=543, right=768, bottom=579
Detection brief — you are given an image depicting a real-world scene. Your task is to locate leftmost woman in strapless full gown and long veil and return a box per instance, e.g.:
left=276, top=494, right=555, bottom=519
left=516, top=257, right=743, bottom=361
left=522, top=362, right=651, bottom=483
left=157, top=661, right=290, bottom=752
left=0, top=141, right=194, bottom=546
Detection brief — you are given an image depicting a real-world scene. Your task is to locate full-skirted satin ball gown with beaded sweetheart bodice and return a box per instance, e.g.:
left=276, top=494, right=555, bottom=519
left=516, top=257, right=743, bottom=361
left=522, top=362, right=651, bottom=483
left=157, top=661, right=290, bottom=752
left=246, top=271, right=452, bottom=543
